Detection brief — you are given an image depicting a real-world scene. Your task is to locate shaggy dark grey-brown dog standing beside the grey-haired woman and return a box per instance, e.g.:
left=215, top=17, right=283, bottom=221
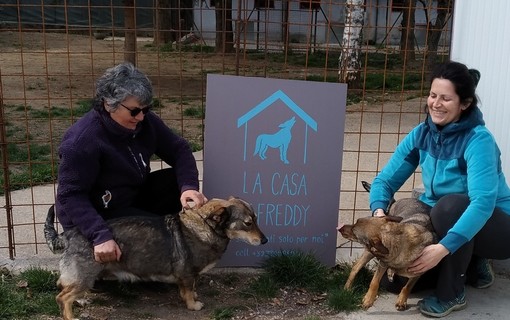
left=45, top=197, right=267, bottom=320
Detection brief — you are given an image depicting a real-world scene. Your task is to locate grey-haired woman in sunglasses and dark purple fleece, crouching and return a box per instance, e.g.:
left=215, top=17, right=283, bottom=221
left=55, top=63, right=207, bottom=263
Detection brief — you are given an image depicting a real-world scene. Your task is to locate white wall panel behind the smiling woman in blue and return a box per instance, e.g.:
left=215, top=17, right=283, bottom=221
left=451, top=0, right=510, bottom=182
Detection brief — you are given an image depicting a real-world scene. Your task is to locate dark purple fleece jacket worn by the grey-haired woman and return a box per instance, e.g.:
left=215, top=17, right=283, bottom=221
left=55, top=104, right=199, bottom=245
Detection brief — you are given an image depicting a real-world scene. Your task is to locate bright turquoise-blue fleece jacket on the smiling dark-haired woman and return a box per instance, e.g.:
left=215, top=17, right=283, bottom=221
left=370, top=107, right=510, bottom=253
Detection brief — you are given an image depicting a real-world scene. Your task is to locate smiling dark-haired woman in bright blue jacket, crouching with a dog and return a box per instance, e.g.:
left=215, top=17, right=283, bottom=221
left=370, top=62, right=510, bottom=317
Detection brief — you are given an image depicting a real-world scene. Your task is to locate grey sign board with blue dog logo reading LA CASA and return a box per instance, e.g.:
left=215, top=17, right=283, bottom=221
left=203, top=75, right=347, bottom=267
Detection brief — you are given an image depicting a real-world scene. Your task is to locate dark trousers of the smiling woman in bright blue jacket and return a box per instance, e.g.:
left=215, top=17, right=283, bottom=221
left=430, top=194, right=510, bottom=301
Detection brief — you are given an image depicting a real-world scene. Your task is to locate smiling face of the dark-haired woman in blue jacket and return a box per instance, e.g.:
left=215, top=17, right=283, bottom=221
left=427, top=78, right=470, bottom=126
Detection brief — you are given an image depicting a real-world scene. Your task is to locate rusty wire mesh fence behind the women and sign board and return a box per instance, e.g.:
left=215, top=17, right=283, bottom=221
left=0, top=0, right=453, bottom=259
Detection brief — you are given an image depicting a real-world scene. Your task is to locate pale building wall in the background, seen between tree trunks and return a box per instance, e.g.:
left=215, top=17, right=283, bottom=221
left=195, top=0, right=451, bottom=47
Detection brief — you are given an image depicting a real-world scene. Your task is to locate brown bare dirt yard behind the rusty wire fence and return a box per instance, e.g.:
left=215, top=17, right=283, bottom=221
left=0, top=29, right=338, bottom=152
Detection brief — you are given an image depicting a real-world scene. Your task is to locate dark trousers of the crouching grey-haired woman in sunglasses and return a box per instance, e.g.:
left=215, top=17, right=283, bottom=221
left=99, top=168, right=182, bottom=220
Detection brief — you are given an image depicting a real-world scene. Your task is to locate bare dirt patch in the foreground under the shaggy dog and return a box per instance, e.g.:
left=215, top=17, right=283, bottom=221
left=36, top=271, right=342, bottom=320
